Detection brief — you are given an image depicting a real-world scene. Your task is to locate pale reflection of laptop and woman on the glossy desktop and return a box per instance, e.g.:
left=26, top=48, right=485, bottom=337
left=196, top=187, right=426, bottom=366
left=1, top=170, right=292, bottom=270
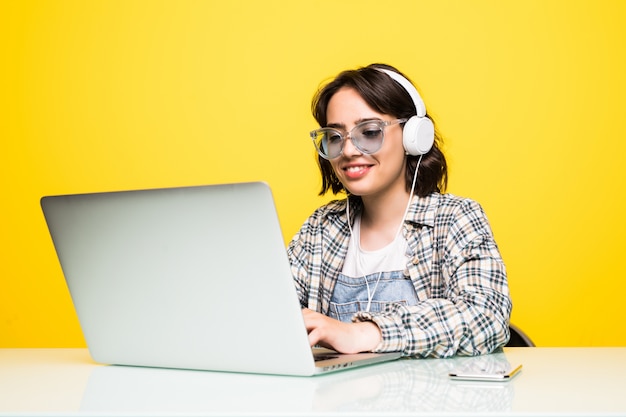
left=80, top=354, right=513, bottom=414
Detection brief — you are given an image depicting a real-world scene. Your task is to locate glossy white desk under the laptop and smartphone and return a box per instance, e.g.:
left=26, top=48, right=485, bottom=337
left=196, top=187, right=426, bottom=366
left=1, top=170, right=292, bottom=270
left=0, top=348, right=626, bottom=416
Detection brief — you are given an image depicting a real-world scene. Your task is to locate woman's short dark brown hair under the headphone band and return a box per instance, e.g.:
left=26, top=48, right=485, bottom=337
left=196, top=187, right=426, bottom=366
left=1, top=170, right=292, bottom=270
left=311, top=64, right=448, bottom=197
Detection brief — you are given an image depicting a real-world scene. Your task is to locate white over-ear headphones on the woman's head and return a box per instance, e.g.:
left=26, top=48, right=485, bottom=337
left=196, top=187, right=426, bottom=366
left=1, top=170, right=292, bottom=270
left=376, top=68, right=435, bottom=156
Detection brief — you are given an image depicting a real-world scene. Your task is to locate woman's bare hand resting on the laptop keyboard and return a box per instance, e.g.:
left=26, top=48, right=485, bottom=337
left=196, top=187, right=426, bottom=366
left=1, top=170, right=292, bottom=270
left=302, top=308, right=382, bottom=353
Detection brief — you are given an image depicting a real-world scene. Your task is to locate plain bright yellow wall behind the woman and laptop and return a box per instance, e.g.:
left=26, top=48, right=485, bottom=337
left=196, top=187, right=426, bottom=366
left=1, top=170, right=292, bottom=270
left=0, top=0, right=626, bottom=347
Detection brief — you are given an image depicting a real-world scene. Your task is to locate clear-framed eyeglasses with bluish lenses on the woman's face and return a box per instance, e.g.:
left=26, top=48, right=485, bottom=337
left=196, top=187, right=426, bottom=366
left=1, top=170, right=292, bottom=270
left=310, top=119, right=408, bottom=159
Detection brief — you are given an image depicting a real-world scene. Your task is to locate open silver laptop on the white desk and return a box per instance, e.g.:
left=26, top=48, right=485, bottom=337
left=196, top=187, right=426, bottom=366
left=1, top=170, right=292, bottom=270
left=41, top=182, right=400, bottom=376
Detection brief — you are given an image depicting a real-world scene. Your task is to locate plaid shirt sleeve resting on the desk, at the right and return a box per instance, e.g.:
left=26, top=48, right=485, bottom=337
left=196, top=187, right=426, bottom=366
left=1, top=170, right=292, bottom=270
left=354, top=200, right=512, bottom=358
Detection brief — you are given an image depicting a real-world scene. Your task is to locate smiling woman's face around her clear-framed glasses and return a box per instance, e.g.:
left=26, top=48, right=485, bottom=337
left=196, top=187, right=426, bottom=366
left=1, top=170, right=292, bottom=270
left=326, top=87, right=407, bottom=202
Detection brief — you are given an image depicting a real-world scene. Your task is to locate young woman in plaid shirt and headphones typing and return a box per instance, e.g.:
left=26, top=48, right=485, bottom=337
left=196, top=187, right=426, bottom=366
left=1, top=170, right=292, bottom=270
left=288, top=64, right=511, bottom=357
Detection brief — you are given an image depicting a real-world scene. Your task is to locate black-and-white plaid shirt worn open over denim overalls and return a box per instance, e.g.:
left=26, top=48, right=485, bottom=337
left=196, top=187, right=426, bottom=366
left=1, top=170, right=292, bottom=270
left=288, top=193, right=512, bottom=357
